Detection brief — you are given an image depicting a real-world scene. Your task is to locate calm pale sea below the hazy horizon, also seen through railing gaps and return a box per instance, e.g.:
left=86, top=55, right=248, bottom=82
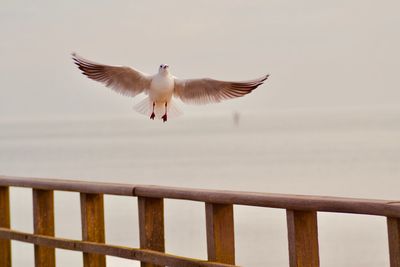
left=0, top=109, right=400, bottom=267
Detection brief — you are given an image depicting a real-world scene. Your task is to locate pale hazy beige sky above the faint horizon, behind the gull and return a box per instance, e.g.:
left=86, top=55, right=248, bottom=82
left=0, top=0, right=400, bottom=119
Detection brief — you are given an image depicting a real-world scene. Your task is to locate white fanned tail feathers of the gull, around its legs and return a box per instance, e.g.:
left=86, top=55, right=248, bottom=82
left=133, top=97, right=183, bottom=119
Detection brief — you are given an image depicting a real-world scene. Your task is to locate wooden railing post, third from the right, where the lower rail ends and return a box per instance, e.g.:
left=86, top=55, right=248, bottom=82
left=206, top=203, right=235, bottom=265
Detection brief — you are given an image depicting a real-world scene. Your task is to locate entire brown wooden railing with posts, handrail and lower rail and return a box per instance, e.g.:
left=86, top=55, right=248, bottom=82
left=0, top=176, right=400, bottom=267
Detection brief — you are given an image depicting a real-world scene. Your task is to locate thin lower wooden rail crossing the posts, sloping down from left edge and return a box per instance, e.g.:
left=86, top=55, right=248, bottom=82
left=0, top=227, right=233, bottom=267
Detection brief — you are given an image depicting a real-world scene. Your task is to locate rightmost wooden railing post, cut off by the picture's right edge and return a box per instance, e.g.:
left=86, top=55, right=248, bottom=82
left=387, top=217, right=400, bottom=267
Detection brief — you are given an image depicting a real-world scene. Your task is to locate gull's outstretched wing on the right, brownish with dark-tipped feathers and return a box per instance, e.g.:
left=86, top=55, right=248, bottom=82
left=174, top=74, right=269, bottom=104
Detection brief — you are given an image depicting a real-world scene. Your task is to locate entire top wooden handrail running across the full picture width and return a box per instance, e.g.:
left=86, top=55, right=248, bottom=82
left=0, top=175, right=400, bottom=217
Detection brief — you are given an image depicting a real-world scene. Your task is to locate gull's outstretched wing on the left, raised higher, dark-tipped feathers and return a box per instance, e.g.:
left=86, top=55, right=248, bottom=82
left=72, top=53, right=151, bottom=96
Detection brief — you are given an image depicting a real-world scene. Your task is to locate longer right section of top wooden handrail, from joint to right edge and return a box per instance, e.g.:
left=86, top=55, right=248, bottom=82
left=134, top=186, right=400, bottom=217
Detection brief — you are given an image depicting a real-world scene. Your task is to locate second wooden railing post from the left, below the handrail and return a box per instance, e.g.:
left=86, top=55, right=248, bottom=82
left=33, top=189, right=56, bottom=267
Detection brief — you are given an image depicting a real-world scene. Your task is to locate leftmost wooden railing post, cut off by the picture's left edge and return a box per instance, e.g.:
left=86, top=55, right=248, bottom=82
left=0, top=186, right=11, bottom=267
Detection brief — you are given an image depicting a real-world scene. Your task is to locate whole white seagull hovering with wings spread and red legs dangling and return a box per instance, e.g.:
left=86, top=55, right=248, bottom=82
left=72, top=53, right=269, bottom=122
